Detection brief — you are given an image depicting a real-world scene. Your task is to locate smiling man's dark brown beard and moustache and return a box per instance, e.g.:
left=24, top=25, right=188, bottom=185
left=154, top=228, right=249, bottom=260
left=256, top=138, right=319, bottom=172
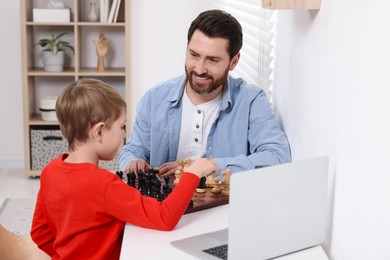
left=185, top=68, right=229, bottom=96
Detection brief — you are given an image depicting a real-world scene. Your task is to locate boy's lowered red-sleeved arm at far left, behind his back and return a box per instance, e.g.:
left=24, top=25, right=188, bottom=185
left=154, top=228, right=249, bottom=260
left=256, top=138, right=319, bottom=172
left=30, top=193, right=54, bottom=256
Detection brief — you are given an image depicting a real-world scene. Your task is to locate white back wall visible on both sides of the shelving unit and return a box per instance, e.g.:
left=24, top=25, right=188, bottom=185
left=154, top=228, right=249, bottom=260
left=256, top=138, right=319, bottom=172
left=0, top=0, right=211, bottom=168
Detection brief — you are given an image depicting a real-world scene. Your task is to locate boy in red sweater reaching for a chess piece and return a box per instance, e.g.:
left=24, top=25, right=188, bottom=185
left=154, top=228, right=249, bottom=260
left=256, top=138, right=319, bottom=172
left=31, top=79, right=217, bottom=259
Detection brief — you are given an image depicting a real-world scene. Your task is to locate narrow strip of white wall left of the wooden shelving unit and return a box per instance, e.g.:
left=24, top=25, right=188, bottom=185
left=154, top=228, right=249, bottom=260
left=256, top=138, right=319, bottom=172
left=0, top=1, right=24, bottom=168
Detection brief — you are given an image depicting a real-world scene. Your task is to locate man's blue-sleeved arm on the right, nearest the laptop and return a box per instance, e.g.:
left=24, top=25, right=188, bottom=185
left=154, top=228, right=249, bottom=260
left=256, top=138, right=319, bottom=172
left=207, top=87, right=291, bottom=175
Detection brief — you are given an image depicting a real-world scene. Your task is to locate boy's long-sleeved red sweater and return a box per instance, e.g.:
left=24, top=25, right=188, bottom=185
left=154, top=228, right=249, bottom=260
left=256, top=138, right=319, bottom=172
left=31, top=154, right=199, bottom=259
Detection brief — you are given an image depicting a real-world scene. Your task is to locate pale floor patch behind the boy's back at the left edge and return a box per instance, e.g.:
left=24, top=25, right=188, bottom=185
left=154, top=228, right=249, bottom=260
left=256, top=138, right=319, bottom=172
left=0, top=169, right=39, bottom=206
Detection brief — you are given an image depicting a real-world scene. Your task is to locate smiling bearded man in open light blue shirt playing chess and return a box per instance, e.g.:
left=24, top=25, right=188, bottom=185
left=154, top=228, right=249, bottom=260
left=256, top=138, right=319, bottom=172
left=120, top=10, right=291, bottom=175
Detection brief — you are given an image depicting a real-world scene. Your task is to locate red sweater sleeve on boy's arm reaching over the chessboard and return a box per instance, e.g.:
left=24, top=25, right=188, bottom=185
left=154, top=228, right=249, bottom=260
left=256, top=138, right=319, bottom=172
left=105, top=173, right=199, bottom=230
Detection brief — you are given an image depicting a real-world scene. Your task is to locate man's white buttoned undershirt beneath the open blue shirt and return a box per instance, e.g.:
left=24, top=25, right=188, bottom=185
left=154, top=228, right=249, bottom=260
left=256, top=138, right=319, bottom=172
left=176, top=91, right=222, bottom=160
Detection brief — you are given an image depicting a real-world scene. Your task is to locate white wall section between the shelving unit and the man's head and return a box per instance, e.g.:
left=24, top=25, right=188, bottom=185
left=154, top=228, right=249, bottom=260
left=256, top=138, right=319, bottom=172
left=130, top=0, right=212, bottom=119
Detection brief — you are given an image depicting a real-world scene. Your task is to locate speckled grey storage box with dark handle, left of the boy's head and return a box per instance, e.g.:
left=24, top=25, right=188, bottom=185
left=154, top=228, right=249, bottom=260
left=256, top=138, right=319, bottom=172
left=30, top=126, right=68, bottom=170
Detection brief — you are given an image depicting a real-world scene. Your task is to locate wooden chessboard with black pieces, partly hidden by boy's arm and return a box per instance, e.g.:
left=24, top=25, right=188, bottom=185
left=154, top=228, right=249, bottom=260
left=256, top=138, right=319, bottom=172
left=116, top=169, right=229, bottom=214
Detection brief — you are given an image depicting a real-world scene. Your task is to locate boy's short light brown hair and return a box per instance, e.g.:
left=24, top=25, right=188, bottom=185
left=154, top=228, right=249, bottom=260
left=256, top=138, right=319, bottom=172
left=56, top=78, right=126, bottom=151
